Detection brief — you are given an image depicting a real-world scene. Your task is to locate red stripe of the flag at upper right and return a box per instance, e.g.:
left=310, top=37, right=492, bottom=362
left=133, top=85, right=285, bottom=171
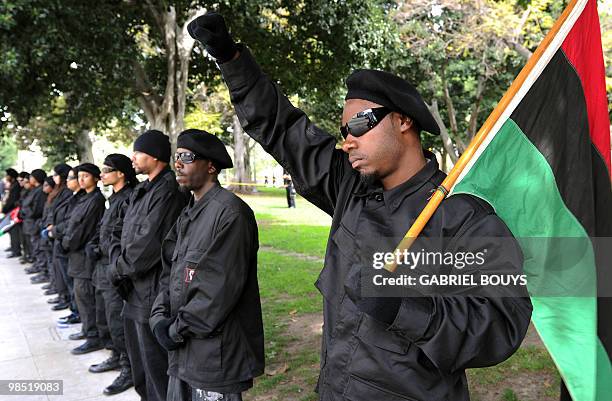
left=561, top=0, right=612, bottom=177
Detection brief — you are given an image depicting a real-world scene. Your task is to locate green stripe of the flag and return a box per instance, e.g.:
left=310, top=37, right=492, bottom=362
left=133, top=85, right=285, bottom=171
left=452, top=119, right=612, bottom=401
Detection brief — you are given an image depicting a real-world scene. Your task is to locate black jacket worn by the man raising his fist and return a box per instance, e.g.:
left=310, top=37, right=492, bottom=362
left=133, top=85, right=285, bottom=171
left=220, top=48, right=531, bottom=401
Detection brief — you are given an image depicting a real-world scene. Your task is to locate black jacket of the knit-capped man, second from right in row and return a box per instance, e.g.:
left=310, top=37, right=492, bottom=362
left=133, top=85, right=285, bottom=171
left=111, top=167, right=187, bottom=323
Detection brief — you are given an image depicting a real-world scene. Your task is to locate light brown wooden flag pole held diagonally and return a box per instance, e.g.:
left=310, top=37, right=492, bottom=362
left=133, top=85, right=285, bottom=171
left=385, top=0, right=579, bottom=272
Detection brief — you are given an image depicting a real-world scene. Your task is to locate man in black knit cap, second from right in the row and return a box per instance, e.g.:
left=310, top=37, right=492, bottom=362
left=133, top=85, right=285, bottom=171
left=111, top=130, right=187, bottom=401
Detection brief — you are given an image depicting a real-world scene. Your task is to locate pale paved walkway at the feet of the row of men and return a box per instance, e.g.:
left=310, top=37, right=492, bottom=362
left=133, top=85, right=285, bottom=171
left=0, top=235, right=139, bottom=401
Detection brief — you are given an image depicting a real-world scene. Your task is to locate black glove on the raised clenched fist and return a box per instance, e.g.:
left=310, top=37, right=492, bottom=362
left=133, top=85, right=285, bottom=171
left=187, top=12, right=238, bottom=64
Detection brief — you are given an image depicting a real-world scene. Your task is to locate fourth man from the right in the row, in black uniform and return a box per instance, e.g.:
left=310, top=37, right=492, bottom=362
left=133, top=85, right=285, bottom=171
left=61, top=163, right=108, bottom=355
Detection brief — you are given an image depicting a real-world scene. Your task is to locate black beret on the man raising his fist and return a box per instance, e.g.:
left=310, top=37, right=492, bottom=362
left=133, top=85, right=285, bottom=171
left=345, top=70, right=440, bottom=135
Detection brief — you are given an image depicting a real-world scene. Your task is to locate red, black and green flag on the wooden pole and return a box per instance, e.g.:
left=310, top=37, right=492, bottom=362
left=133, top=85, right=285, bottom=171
left=451, top=0, right=612, bottom=401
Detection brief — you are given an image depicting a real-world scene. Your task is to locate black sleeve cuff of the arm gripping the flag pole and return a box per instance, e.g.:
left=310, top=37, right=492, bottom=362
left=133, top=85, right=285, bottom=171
left=387, top=297, right=436, bottom=342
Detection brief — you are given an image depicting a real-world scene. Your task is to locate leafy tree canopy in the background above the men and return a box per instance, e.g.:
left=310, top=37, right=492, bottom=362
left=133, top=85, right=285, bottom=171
left=0, top=0, right=612, bottom=176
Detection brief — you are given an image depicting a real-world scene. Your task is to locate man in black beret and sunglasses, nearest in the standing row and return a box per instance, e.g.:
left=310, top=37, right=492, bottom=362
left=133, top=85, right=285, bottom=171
left=150, top=129, right=264, bottom=401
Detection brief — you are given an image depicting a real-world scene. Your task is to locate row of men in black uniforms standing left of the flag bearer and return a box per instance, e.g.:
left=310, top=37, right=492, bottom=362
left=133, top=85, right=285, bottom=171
left=5, top=130, right=264, bottom=401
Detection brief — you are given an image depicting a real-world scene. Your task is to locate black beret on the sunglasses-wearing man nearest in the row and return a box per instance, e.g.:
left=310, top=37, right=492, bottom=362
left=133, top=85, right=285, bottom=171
left=176, top=129, right=234, bottom=169
